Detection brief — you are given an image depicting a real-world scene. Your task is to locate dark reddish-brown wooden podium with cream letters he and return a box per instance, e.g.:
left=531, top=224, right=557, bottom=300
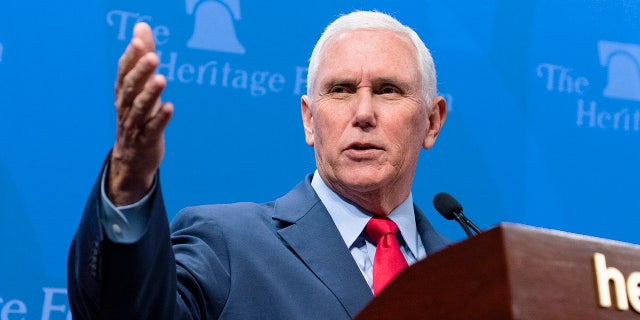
left=356, top=223, right=640, bottom=320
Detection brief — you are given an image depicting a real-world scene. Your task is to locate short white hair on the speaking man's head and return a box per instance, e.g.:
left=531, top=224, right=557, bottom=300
left=307, top=11, right=437, bottom=109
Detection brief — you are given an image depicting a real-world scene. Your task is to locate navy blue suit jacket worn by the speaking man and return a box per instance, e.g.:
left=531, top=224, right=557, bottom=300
left=68, top=175, right=449, bottom=319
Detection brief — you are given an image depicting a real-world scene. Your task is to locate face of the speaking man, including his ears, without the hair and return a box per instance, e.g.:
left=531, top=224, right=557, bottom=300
left=302, top=30, right=446, bottom=213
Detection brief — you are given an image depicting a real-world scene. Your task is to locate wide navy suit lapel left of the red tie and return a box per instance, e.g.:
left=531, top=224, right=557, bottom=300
left=274, top=176, right=373, bottom=318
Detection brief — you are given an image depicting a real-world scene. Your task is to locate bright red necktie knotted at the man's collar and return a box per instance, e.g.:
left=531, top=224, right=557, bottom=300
left=364, top=217, right=408, bottom=295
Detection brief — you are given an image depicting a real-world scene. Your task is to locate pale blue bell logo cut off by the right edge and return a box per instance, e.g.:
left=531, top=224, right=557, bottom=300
left=598, top=41, right=640, bottom=101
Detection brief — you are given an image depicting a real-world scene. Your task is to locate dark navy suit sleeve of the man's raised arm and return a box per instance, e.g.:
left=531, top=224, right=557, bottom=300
left=67, top=162, right=181, bottom=319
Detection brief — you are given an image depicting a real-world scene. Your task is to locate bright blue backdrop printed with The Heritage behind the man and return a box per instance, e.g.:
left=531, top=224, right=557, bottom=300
left=0, top=0, right=640, bottom=320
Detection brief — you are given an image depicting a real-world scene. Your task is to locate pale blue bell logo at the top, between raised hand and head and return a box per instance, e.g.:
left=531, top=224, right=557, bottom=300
left=185, top=0, right=245, bottom=54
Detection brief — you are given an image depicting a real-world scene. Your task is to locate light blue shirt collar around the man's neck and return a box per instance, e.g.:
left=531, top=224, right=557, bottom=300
left=311, top=170, right=420, bottom=257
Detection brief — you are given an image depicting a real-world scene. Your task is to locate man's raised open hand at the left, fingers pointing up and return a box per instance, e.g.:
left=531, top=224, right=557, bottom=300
left=107, top=23, right=173, bottom=205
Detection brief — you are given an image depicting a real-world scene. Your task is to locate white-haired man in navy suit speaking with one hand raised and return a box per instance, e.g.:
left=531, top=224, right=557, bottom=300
left=69, top=12, right=449, bottom=319
